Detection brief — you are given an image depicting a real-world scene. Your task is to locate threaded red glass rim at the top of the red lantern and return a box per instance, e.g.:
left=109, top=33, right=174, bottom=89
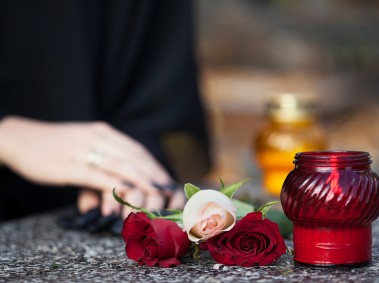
left=294, top=150, right=372, bottom=166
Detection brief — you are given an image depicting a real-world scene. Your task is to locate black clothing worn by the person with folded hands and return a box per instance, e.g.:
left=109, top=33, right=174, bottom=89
left=0, top=0, right=207, bottom=220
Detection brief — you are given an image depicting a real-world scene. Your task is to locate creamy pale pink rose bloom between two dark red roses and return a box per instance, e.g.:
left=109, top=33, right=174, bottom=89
left=183, top=190, right=236, bottom=242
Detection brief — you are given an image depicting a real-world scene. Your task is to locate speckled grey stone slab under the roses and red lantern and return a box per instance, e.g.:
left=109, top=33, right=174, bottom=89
left=0, top=213, right=379, bottom=282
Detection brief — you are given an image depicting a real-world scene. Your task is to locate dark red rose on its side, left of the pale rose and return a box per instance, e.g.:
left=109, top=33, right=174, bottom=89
left=122, top=212, right=190, bottom=267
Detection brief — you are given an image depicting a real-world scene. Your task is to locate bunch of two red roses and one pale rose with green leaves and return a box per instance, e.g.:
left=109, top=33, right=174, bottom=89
left=113, top=179, right=286, bottom=267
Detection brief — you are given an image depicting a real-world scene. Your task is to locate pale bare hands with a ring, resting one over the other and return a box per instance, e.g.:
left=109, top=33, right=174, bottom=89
left=0, top=116, right=184, bottom=215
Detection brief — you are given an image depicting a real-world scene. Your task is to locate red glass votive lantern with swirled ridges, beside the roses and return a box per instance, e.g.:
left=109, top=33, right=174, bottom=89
left=280, top=151, right=379, bottom=266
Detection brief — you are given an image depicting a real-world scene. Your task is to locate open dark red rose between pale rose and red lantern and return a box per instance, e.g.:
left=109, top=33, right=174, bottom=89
left=206, top=212, right=286, bottom=267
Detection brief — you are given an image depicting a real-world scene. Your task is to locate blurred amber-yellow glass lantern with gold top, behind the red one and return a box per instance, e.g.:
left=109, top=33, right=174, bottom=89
left=253, top=94, right=326, bottom=197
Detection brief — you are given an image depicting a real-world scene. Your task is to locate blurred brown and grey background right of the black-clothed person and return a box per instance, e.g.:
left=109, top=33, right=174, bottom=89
left=195, top=0, right=379, bottom=195
